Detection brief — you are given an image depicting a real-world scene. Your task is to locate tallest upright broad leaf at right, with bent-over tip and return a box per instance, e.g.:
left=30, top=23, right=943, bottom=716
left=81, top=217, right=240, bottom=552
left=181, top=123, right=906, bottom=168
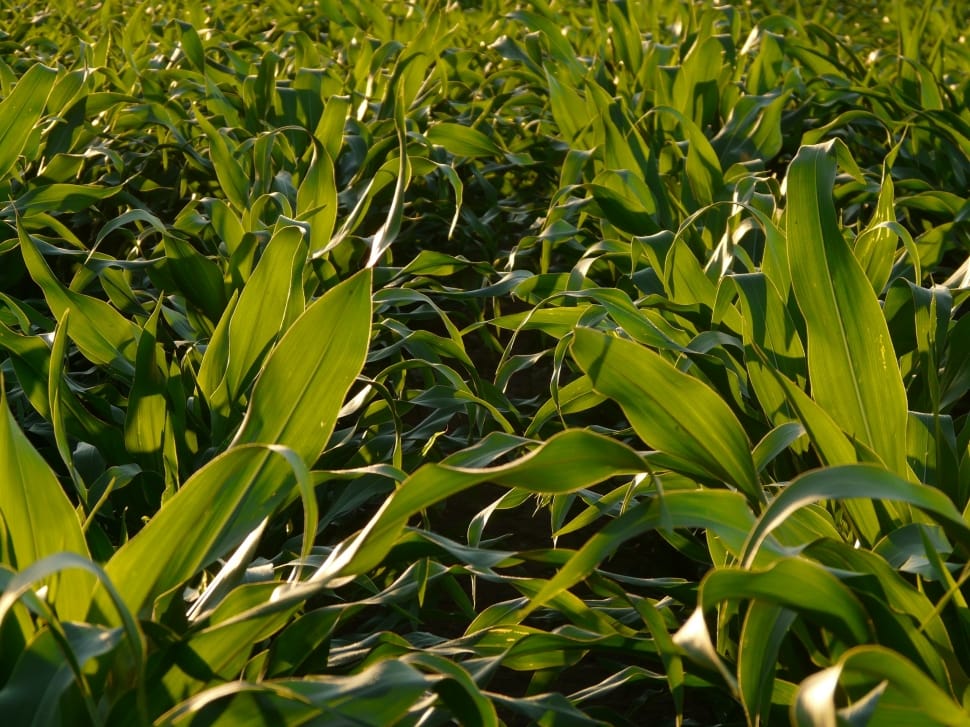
left=786, top=142, right=907, bottom=477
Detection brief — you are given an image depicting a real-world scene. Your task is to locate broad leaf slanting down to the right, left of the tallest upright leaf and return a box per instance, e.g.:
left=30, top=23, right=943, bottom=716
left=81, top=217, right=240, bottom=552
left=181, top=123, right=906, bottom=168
left=572, top=328, right=764, bottom=502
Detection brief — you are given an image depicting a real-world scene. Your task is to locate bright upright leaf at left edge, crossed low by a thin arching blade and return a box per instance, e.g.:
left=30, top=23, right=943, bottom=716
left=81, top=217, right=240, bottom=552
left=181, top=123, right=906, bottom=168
left=0, top=381, right=93, bottom=620
